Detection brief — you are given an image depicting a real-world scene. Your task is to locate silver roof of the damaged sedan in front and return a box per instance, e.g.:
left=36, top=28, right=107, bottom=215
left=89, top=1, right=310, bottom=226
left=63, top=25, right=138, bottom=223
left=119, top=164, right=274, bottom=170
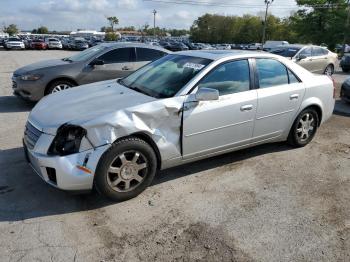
left=175, top=50, right=276, bottom=60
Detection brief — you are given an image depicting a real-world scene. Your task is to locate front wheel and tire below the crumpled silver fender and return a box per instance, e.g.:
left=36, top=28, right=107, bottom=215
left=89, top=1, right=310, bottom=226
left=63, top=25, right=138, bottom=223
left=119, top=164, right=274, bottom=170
left=94, top=137, right=157, bottom=202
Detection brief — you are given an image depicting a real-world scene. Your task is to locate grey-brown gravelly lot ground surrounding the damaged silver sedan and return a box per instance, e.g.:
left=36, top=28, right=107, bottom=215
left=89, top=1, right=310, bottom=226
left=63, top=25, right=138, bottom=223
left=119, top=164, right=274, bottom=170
left=0, top=51, right=350, bottom=261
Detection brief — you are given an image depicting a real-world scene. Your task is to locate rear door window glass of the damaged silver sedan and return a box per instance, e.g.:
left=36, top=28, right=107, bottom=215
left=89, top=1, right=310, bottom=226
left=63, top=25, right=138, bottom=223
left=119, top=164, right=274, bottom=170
left=256, top=59, right=289, bottom=88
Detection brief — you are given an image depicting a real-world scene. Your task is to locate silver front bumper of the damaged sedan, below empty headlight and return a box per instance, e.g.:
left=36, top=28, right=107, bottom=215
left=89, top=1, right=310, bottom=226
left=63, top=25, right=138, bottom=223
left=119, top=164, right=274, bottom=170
left=23, top=133, right=110, bottom=191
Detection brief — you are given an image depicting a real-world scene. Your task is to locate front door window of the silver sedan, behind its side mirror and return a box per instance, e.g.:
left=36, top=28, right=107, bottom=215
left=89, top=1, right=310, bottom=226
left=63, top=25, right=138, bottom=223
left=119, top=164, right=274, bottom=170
left=198, top=60, right=250, bottom=95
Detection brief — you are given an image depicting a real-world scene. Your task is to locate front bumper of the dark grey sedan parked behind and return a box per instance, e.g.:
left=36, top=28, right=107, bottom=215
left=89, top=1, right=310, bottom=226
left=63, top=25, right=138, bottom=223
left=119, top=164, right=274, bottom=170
left=12, top=76, right=47, bottom=102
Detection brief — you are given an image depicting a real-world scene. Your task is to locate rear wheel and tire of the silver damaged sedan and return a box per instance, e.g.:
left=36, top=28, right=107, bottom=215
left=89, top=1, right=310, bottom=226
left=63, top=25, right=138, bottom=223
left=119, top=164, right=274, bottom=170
left=288, top=108, right=319, bottom=147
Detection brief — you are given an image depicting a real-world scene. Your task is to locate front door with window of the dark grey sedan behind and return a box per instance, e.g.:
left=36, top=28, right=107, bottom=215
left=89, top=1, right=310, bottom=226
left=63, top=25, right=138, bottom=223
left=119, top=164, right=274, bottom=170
left=82, top=48, right=135, bottom=83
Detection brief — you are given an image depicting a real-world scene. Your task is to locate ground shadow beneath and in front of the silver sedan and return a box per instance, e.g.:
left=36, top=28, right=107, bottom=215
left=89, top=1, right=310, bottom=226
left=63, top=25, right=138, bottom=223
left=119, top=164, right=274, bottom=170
left=0, top=143, right=291, bottom=222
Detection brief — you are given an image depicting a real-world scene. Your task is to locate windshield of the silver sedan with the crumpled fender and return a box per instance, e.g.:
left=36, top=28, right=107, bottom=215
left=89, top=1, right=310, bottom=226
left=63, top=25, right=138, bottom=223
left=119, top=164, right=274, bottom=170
left=120, top=55, right=212, bottom=98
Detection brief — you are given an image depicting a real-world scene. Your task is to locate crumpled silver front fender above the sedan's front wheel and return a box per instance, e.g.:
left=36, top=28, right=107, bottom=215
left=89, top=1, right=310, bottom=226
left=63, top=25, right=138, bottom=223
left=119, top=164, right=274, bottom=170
left=76, top=96, right=185, bottom=165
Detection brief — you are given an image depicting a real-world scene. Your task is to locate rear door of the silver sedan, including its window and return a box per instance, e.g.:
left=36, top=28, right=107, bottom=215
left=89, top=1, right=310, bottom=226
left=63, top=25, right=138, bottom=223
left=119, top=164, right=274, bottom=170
left=253, top=58, right=305, bottom=141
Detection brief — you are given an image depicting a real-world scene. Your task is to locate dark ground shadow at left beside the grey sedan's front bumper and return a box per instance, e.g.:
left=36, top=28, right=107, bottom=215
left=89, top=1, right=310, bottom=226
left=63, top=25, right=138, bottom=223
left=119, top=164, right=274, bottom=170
left=0, top=96, right=35, bottom=113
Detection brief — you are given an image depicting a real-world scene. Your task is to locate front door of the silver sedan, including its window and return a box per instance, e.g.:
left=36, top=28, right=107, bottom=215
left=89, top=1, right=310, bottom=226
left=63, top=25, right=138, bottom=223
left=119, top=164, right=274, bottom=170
left=182, top=59, right=257, bottom=159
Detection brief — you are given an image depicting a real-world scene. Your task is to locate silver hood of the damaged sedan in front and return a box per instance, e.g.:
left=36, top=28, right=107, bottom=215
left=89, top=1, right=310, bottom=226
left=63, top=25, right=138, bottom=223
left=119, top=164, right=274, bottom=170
left=29, top=79, right=156, bottom=135
